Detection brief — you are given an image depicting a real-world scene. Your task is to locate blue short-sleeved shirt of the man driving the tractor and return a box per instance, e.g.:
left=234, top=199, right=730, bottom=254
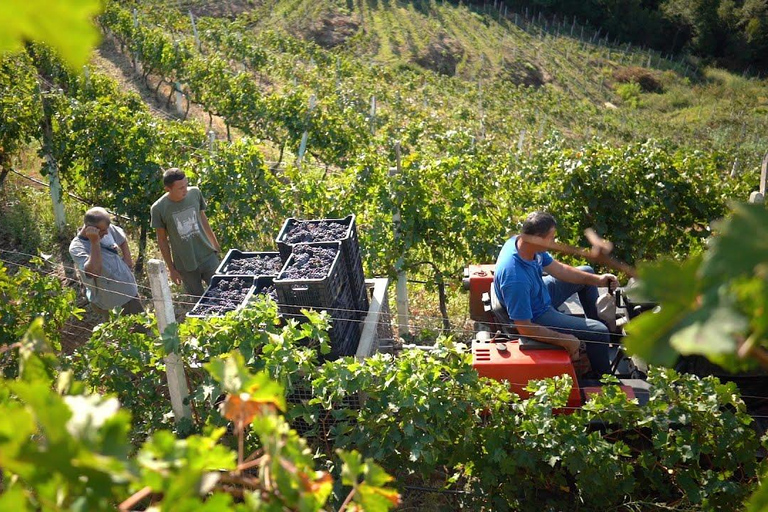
left=493, top=236, right=553, bottom=320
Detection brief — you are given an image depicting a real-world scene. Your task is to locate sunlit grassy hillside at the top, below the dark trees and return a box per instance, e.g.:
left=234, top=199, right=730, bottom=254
left=150, top=0, right=768, bottom=172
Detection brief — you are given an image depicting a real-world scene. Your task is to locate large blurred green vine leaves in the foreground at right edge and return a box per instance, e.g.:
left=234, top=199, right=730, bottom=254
left=626, top=204, right=768, bottom=366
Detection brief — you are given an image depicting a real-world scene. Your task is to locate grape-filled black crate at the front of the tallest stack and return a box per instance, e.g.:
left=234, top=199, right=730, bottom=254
left=274, top=242, right=355, bottom=316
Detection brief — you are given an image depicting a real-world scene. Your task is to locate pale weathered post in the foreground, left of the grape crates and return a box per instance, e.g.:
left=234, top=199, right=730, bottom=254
left=147, top=259, right=192, bottom=423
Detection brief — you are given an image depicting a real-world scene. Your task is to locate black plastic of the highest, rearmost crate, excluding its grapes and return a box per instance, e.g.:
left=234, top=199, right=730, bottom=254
left=275, top=215, right=368, bottom=317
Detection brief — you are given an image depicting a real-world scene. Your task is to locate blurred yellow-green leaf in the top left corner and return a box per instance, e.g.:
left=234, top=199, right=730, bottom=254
left=0, top=0, right=101, bottom=68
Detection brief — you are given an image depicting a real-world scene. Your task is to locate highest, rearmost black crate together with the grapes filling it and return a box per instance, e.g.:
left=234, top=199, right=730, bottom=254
left=275, top=215, right=368, bottom=318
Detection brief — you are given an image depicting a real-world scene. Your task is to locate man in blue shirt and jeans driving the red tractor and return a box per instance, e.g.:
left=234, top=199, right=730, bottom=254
left=493, top=212, right=618, bottom=375
